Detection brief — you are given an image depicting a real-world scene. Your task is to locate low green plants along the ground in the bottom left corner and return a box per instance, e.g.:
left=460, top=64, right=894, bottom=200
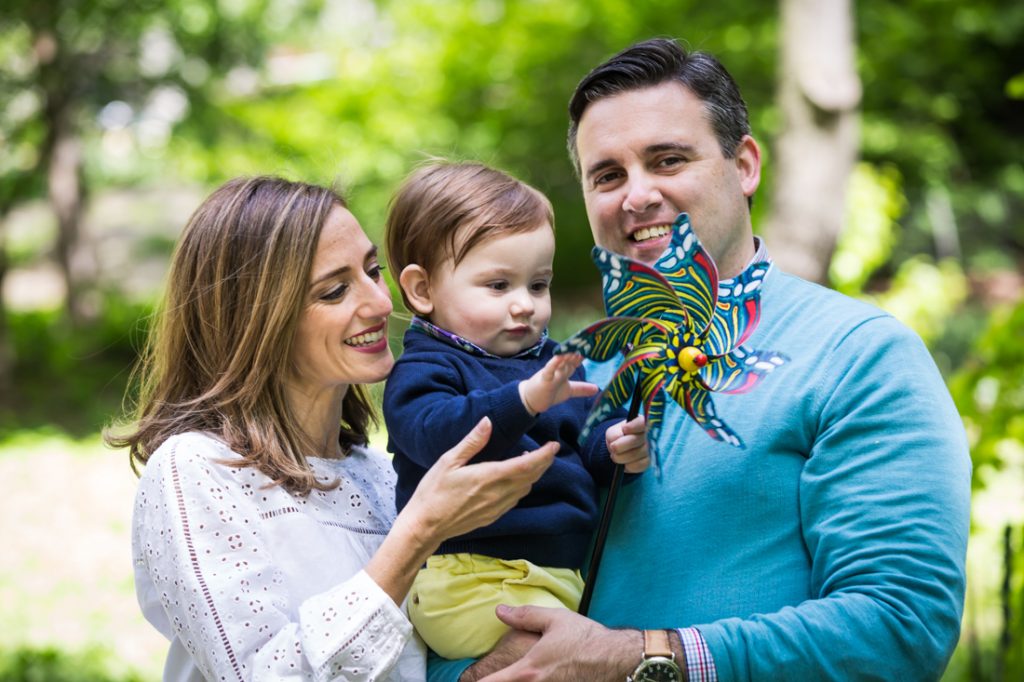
left=0, top=647, right=143, bottom=682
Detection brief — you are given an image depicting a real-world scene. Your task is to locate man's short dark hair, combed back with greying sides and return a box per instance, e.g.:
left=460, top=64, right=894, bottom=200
left=568, top=38, right=751, bottom=175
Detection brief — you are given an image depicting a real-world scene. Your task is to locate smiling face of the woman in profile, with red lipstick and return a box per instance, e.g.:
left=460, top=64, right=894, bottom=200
left=292, top=206, right=394, bottom=396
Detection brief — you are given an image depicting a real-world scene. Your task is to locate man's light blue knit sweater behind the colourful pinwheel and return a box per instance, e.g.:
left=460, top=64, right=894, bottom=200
left=431, top=268, right=971, bottom=682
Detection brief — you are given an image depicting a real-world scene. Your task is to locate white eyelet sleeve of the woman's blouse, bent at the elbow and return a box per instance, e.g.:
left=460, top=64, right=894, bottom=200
left=133, top=437, right=412, bottom=680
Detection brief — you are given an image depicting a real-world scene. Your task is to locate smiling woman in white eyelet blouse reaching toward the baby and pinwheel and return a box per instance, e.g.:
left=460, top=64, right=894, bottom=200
left=108, top=177, right=557, bottom=680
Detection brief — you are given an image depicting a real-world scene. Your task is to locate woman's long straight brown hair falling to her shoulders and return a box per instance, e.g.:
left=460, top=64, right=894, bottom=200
left=104, top=177, right=376, bottom=495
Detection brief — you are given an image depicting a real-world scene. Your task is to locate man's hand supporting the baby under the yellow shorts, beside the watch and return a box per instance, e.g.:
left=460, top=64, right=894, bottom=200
left=461, top=606, right=643, bottom=682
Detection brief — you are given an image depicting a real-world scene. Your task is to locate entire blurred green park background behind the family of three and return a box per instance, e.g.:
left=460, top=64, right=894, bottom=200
left=0, top=0, right=1024, bottom=680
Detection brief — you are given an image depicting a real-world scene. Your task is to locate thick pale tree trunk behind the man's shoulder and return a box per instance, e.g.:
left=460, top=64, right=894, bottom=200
left=765, top=0, right=861, bottom=283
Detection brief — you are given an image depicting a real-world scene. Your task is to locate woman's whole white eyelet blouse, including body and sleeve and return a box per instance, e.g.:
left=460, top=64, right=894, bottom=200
left=132, top=433, right=425, bottom=682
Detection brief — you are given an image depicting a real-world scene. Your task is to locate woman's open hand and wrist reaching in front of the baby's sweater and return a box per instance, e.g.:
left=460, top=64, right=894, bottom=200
left=366, top=418, right=558, bottom=603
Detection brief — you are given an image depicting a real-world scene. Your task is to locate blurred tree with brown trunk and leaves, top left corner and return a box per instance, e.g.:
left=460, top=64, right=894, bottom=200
left=0, top=0, right=319, bottom=322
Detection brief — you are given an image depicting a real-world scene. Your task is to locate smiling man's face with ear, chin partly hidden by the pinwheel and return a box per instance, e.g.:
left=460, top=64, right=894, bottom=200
left=577, top=82, right=761, bottom=279
